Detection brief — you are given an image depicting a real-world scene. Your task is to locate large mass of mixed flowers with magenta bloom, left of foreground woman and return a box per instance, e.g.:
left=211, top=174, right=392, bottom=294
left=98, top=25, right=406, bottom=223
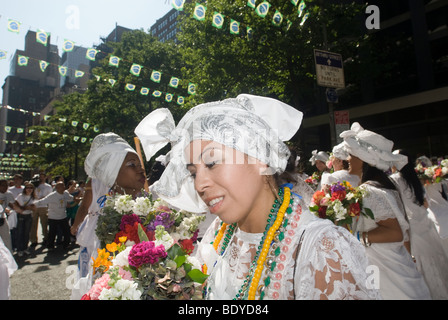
left=83, top=195, right=207, bottom=300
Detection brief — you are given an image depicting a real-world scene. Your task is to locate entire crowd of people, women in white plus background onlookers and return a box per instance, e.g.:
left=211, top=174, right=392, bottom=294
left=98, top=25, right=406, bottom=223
left=0, top=94, right=448, bottom=300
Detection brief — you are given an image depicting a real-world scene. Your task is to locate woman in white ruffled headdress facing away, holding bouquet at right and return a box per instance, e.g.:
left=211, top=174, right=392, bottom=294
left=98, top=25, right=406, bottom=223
left=340, top=122, right=431, bottom=300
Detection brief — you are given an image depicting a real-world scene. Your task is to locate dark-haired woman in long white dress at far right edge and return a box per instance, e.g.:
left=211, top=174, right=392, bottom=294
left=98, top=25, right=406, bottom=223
left=390, top=150, right=448, bottom=300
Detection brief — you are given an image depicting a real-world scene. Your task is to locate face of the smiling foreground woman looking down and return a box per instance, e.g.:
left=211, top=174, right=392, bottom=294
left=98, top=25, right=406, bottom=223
left=185, top=140, right=274, bottom=232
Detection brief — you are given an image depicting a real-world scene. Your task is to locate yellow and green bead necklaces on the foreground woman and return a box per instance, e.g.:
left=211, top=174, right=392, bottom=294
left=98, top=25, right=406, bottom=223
left=207, top=186, right=300, bottom=300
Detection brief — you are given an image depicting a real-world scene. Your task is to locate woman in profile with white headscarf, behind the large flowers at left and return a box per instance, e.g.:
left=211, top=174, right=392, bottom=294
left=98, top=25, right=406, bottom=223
left=70, top=133, right=146, bottom=300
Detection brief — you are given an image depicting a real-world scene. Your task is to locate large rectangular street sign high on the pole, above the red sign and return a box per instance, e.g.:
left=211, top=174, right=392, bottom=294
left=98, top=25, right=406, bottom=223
left=314, top=49, right=345, bottom=88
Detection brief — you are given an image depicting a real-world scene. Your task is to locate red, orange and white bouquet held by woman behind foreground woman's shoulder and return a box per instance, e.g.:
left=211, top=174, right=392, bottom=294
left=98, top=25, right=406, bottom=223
left=310, top=181, right=373, bottom=226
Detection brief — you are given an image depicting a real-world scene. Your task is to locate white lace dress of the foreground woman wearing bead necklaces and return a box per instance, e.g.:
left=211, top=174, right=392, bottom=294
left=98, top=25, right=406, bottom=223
left=196, top=194, right=380, bottom=300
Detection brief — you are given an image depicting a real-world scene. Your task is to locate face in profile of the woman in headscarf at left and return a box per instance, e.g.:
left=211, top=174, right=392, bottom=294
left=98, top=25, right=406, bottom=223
left=116, top=152, right=146, bottom=194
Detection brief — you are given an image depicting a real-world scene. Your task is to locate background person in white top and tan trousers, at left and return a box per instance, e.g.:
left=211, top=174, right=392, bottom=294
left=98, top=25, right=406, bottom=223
left=30, top=172, right=53, bottom=246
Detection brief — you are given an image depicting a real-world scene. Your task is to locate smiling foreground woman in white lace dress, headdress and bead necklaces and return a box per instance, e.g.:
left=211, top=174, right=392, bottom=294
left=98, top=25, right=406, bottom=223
left=136, top=94, right=379, bottom=300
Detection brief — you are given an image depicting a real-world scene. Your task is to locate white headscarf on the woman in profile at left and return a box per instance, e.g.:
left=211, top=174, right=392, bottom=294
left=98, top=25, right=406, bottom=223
left=84, top=132, right=137, bottom=188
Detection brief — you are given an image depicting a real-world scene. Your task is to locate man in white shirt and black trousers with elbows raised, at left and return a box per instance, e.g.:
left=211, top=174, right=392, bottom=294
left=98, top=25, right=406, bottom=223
left=34, top=182, right=79, bottom=251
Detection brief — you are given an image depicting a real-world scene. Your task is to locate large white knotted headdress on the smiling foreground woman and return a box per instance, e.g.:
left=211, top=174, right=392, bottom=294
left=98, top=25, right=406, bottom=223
left=135, top=94, right=303, bottom=212
